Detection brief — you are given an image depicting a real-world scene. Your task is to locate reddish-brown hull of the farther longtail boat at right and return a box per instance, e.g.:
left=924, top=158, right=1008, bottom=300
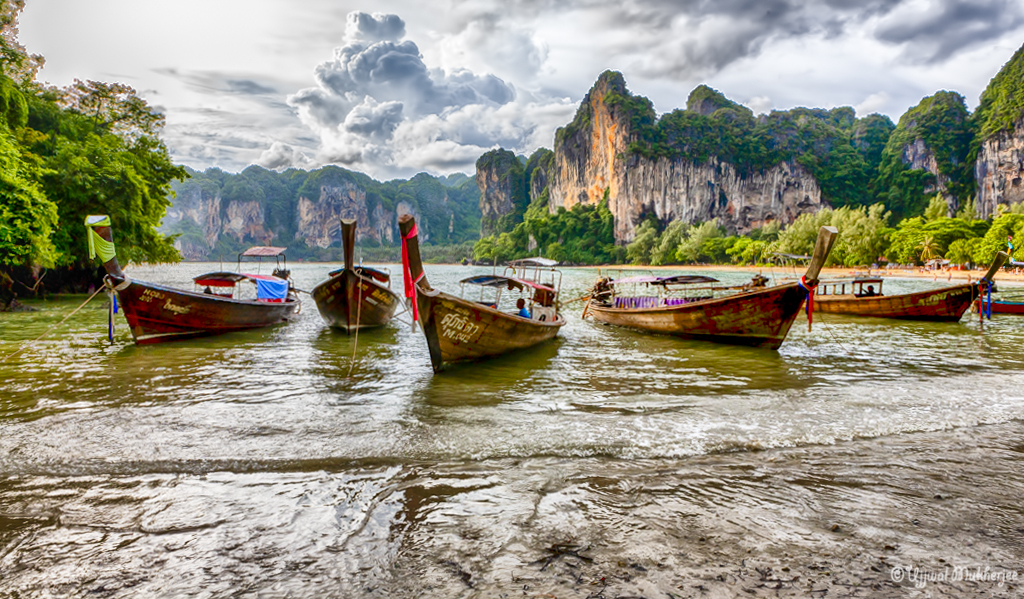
left=814, top=285, right=974, bottom=323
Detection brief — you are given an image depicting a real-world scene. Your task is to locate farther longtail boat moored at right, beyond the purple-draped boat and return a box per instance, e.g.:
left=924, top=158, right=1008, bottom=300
left=814, top=252, right=1007, bottom=323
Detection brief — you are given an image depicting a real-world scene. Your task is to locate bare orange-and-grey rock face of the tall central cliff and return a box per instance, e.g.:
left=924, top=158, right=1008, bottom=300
left=545, top=76, right=827, bottom=243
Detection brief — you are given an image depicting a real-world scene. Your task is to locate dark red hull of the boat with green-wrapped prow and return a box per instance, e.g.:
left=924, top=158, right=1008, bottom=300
left=114, top=281, right=299, bottom=345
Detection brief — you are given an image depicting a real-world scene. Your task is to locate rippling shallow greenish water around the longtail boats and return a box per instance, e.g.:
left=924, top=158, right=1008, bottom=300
left=0, top=264, right=1024, bottom=597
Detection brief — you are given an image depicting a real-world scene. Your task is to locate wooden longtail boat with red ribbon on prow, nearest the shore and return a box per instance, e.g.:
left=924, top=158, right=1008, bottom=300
left=398, top=214, right=565, bottom=373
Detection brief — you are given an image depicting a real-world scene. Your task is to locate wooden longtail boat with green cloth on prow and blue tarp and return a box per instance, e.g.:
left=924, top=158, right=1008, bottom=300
left=85, top=216, right=299, bottom=344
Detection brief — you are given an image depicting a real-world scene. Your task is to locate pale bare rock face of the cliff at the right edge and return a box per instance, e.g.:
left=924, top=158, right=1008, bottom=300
left=974, top=121, right=1024, bottom=218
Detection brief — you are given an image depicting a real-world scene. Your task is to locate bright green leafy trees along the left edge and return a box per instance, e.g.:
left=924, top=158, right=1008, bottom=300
left=0, top=2, right=186, bottom=268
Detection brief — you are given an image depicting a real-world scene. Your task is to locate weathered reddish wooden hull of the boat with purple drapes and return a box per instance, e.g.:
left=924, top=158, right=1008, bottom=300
left=588, top=284, right=807, bottom=349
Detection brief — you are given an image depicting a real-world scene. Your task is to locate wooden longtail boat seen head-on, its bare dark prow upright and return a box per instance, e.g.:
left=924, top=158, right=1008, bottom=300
left=311, top=219, right=401, bottom=333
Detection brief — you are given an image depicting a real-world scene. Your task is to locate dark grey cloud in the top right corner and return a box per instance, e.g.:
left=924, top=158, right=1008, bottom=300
left=878, top=0, right=1024, bottom=62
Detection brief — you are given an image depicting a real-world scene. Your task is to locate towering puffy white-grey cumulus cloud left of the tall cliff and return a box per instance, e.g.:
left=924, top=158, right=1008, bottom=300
left=276, top=12, right=575, bottom=177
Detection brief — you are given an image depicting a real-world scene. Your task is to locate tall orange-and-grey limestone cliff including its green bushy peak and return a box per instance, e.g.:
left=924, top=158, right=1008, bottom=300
left=543, top=72, right=864, bottom=243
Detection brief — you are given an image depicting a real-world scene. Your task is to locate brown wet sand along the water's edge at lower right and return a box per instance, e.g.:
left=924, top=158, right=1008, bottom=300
left=403, top=422, right=1024, bottom=599
